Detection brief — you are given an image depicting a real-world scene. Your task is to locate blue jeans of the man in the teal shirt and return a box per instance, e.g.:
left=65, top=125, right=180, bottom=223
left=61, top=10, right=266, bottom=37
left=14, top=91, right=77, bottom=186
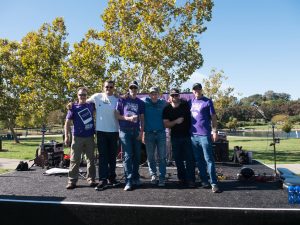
left=145, top=130, right=167, bottom=179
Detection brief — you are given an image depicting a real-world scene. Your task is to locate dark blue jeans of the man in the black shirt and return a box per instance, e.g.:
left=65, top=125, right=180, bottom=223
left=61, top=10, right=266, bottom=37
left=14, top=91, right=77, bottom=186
left=171, top=137, right=195, bottom=182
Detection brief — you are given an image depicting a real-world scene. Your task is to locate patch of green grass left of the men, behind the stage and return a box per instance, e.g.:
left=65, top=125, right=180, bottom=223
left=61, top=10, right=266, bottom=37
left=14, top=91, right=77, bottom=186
left=0, top=137, right=62, bottom=160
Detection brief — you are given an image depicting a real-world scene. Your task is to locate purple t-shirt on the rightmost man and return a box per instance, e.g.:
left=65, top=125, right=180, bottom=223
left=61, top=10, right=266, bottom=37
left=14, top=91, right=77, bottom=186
left=189, top=96, right=216, bottom=135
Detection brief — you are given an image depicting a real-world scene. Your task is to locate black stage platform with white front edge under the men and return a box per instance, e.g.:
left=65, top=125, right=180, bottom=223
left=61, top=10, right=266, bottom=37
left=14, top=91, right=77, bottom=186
left=0, top=160, right=300, bottom=225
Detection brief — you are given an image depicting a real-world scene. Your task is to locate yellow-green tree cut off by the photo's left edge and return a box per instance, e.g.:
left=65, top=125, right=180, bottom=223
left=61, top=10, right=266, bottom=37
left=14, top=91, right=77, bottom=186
left=0, top=39, right=24, bottom=143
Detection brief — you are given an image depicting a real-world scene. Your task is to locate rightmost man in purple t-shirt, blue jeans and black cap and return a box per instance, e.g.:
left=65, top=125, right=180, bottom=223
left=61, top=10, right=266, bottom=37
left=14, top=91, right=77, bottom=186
left=190, top=83, right=221, bottom=193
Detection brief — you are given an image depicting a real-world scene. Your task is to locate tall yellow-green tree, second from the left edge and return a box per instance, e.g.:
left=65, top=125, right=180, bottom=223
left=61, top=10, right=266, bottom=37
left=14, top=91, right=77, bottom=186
left=14, top=18, right=69, bottom=125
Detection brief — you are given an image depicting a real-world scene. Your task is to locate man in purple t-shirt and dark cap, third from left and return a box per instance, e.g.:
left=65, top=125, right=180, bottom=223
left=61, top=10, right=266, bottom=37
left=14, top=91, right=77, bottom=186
left=116, top=81, right=145, bottom=191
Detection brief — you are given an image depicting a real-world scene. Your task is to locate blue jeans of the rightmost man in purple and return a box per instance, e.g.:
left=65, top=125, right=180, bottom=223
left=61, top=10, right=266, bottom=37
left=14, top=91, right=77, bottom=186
left=191, top=135, right=218, bottom=184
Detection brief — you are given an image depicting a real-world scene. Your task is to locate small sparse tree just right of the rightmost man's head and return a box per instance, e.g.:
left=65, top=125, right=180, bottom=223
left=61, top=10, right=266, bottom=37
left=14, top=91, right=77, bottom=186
left=202, top=69, right=237, bottom=122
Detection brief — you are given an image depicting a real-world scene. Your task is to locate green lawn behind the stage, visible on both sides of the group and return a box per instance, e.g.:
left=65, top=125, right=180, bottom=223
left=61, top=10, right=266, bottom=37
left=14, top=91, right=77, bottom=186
left=0, top=136, right=300, bottom=164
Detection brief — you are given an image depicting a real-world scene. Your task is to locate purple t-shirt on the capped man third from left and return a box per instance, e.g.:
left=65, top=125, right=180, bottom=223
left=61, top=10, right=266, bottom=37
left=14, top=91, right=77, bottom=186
left=116, top=98, right=145, bottom=129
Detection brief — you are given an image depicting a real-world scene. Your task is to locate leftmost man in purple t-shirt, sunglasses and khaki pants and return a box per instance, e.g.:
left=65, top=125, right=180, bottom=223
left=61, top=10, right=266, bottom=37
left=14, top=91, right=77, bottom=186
left=65, top=87, right=96, bottom=189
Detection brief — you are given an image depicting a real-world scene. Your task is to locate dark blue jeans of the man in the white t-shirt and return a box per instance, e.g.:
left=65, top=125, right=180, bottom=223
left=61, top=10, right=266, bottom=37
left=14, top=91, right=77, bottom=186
left=97, top=131, right=119, bottom=180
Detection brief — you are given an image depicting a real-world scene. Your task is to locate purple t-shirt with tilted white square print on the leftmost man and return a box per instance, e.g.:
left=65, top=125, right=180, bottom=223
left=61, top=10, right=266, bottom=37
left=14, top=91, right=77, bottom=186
left=66, top=103, right=95, bottom=137
